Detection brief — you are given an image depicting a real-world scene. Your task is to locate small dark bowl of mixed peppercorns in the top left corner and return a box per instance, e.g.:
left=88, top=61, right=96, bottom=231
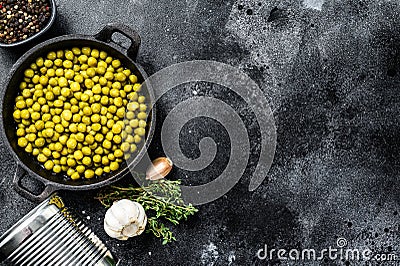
left=0, top=0, right=56, bottom=47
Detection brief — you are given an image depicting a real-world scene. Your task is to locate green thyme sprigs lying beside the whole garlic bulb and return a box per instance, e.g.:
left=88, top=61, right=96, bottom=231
left=96, top=179, right=198, bottom=244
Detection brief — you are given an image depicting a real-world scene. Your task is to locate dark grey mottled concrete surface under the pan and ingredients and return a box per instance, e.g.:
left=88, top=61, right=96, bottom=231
left=0, top=0, right=400, bottom=265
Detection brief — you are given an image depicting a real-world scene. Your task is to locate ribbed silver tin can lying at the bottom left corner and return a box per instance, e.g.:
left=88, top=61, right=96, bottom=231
left=0, top=194, right=117, bottom=266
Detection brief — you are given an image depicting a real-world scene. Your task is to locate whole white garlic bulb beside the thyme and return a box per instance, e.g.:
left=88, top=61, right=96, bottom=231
left=104, top=199, right=147, bottom=240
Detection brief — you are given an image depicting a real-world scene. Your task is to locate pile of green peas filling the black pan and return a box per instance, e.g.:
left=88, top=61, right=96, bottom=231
left=13, top=47, right=147, bottom=180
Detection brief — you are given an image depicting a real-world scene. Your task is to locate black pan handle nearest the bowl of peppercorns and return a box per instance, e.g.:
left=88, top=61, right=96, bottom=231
left=94, top=23, right=141, bottom=61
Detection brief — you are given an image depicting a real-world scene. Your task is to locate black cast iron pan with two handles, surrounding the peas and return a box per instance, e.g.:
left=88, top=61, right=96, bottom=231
left=1, top=24, right=155, bottom=202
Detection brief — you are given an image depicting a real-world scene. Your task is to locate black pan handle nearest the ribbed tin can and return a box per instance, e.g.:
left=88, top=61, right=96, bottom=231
left=13, top=164, right=56, bottom=202
